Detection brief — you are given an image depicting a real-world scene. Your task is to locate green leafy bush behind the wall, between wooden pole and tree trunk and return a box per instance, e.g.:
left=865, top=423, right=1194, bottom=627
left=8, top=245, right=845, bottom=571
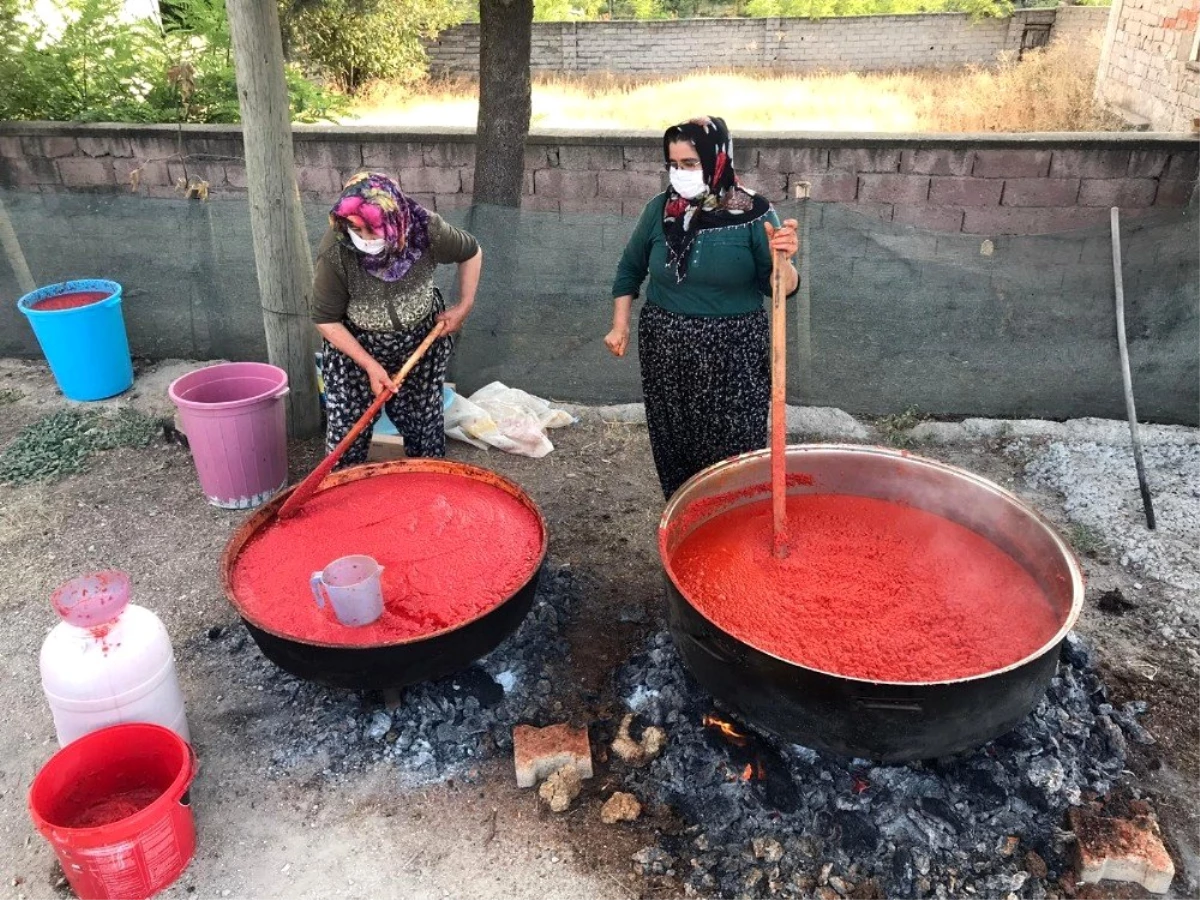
left=281, top=0, right=468, bottom=91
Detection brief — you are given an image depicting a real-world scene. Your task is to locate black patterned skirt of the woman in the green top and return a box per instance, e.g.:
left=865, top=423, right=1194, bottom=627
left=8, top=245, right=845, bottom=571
left=637, top=304, right=770, bottom=498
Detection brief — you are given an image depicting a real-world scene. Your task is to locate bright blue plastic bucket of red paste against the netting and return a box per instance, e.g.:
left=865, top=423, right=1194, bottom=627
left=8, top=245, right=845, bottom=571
left=17, top=278, right=133, bottom=400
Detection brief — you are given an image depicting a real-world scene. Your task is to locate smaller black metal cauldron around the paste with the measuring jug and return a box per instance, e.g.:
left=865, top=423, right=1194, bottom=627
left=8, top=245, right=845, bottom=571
left=221, top=460, right=546, bottom=690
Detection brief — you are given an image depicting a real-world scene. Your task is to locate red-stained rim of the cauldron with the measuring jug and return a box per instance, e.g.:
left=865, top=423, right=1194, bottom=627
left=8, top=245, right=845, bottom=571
left=221, top=457, right=550, bottom=650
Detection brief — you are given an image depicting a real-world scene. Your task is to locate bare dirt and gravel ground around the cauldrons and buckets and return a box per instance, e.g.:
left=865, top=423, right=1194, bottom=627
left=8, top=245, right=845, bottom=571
left=0, top=360, right=1200, bottom=900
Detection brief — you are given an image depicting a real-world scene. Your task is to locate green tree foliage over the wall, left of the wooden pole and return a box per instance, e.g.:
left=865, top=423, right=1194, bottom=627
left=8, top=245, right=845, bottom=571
left=0, top=0, right=344, bottom=122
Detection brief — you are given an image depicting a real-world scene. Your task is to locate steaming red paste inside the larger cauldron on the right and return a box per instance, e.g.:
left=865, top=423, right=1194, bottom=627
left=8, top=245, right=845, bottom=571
left=670, top=494, right=1061, bottom=682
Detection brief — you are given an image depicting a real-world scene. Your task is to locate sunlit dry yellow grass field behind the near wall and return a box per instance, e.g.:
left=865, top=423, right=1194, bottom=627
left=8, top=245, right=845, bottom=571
left=344, top=43, right=1120, bottom=132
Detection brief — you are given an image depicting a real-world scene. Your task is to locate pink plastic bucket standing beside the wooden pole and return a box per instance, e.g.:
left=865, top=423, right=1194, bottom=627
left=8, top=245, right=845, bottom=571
left=168, top=362, right=288, bottom=509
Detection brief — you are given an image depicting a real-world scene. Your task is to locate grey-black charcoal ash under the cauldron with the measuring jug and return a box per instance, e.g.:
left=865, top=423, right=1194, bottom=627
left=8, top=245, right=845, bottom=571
left=182, top=565, right=581, bottom=784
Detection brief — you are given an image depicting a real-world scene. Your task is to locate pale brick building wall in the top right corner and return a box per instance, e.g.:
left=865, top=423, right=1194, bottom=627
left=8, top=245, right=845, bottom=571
left=1097, top=0, right=1200, bottom=132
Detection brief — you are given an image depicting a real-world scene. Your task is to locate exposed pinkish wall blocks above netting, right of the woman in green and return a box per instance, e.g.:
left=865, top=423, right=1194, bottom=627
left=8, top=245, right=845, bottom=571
left=742, top=136, right=1200, bottom=235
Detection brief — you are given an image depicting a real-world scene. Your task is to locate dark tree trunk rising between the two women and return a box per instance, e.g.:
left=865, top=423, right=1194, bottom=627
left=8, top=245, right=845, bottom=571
left=474, top=0, right=533, bottom=206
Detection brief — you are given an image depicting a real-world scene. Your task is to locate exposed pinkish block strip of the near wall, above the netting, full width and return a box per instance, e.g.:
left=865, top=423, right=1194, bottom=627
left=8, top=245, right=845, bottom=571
left=0, top=122, right=1200, bottom=235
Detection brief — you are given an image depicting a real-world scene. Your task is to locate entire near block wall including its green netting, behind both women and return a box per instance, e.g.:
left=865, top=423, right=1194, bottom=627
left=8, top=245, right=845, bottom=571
left=0, top=122, right=1200, bottom=425
